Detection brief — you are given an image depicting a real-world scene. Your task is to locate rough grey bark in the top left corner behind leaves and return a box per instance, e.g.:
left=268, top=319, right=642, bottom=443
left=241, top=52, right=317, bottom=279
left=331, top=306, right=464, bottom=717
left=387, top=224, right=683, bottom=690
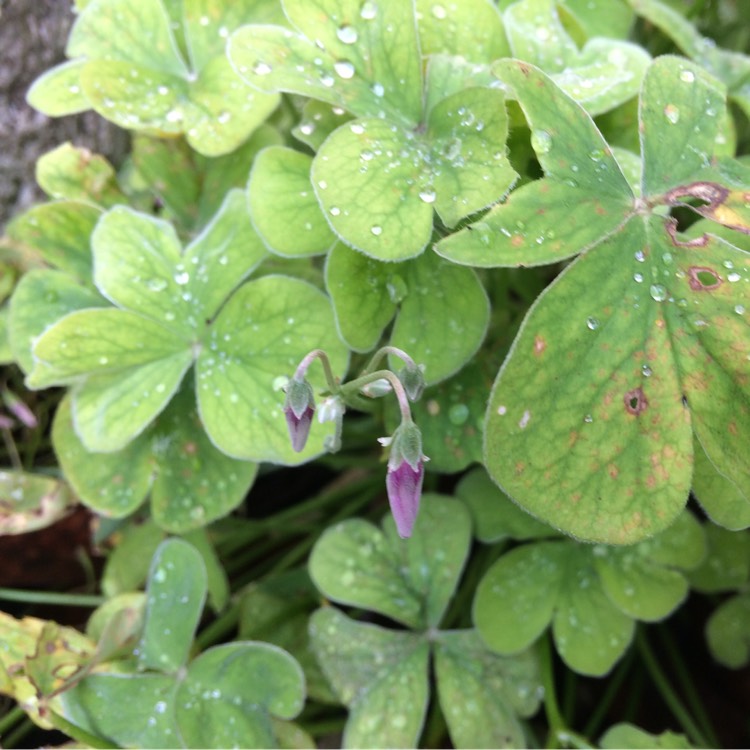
left=0, top=0, right=129, bottom=226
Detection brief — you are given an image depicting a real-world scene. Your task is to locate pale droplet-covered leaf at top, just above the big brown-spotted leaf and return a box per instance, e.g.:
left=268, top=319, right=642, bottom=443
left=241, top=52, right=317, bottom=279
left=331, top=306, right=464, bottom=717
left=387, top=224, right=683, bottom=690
left=503, top=0, right=650, bottom=115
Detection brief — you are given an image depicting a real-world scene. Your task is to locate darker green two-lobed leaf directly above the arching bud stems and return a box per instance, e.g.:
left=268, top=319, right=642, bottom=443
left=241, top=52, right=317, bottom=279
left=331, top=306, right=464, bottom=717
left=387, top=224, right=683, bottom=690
left=326, top=244, right=489, bottom=383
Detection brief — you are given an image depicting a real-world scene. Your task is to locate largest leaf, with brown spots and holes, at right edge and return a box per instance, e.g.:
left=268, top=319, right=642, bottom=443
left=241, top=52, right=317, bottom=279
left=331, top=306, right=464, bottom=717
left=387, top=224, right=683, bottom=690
left=436, top=57, right=750, bottom=543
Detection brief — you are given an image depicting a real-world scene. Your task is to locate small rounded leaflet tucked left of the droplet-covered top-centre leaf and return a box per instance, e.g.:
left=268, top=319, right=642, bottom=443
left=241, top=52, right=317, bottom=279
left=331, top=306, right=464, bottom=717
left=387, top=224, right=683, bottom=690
left=247, top=146, right=335, bottom=258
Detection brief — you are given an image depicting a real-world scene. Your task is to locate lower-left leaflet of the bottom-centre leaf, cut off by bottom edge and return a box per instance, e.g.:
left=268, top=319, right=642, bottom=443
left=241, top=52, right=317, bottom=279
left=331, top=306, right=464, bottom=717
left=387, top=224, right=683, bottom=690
left=310, top=608, right=429, bottom=748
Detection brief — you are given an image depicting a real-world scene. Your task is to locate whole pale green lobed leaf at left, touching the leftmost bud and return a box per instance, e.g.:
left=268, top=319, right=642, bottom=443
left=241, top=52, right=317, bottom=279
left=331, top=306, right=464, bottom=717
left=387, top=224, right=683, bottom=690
left=28, top=190, right=346, bottom=461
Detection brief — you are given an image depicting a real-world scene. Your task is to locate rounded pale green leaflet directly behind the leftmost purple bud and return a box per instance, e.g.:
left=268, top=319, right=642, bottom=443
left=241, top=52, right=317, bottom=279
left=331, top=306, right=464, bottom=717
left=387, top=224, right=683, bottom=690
left=196, top=276, right=348, bottom=464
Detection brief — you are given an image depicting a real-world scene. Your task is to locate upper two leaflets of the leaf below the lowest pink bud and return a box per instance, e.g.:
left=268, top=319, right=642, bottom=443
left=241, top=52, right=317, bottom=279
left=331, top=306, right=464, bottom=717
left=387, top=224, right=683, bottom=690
left=309, top=494, right=471, bottom=628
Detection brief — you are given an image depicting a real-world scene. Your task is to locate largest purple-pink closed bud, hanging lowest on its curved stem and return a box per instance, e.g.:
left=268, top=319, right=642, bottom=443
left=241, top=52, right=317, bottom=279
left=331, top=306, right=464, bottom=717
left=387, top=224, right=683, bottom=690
left=381, top=422, right=427, bottom=539
